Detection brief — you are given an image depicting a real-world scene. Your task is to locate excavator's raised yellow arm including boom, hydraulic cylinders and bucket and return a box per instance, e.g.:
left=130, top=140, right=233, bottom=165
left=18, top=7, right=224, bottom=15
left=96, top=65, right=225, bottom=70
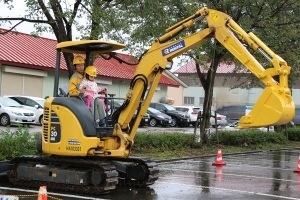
left=118, top=7, right=295, bottom=142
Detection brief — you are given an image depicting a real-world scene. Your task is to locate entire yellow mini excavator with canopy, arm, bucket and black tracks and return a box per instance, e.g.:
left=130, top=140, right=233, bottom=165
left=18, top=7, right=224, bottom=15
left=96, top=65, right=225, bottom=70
left=8, top=7, right=295, bottom=194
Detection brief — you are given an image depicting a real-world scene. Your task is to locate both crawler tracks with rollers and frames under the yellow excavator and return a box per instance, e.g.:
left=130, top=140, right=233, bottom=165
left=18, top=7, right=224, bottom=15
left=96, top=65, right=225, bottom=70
left=7, top=156, right=159, bottom=195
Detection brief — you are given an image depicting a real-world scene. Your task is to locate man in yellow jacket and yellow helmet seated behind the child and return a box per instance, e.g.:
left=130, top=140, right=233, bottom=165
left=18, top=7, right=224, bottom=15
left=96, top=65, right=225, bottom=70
left=69, top=56, right=106, bottom=125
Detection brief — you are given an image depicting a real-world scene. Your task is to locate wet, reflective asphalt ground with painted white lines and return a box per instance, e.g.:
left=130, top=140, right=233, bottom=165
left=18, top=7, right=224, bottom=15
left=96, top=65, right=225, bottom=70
left=0, top=125, right=300, bottom=200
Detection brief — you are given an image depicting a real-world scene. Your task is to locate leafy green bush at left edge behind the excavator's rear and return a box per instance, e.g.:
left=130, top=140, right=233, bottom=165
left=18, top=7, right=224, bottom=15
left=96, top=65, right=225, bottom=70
left=0, top=127, right=37, bottom=160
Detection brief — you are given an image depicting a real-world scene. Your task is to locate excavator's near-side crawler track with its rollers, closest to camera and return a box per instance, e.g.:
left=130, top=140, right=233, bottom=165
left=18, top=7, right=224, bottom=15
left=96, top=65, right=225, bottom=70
left=8, top=156, right=118, bottom=194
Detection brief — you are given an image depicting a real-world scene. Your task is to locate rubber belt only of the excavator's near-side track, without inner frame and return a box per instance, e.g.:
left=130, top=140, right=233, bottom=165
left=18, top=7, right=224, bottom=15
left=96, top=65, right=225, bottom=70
left=8, top=156, right=118, bottom=194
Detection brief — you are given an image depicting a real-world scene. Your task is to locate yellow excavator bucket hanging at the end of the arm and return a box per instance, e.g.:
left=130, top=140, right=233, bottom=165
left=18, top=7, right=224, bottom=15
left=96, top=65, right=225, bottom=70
left=239, top=87, right=295, bottom=128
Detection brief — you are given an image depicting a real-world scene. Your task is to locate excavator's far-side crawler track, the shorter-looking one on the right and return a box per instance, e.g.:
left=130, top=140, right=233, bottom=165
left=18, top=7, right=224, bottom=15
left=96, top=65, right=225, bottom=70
left=113, top=157, right=159, bottom=187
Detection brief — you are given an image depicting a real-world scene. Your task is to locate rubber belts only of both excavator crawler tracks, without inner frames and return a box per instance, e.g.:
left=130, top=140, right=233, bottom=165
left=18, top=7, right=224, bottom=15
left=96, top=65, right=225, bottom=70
left=8, top=156, right=159, bottom=195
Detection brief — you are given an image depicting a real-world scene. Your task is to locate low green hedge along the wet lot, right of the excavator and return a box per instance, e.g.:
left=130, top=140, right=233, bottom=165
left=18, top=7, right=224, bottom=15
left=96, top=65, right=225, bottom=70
left=133, top=128, right=300, bottom=152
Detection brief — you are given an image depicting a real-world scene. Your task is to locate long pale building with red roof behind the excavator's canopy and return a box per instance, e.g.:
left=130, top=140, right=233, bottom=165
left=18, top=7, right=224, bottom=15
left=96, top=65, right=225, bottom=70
left=0, top=29, right=181, bottom=101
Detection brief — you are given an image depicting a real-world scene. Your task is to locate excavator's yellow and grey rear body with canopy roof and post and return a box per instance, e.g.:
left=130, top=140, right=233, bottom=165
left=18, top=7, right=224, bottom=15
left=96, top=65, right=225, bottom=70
left=39, top=40, right=125, bottom=156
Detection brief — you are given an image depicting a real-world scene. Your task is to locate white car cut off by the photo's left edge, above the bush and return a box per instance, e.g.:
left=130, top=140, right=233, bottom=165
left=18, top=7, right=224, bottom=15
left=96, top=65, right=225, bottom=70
left=0, top=97, right=36, bottom=126
